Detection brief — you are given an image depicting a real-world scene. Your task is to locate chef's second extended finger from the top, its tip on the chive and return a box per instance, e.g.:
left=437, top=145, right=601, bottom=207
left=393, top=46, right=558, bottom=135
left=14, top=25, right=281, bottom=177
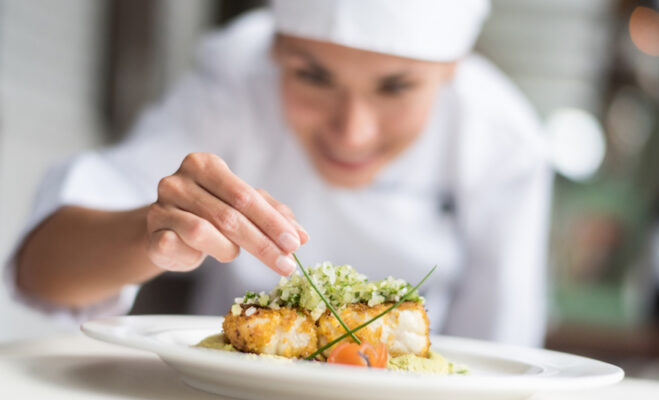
left=159, top=179, right=296, bottom=276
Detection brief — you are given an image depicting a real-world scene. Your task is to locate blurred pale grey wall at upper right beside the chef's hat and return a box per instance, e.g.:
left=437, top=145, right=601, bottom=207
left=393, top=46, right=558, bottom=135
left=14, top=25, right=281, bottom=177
left=477, top=0, right=617, bottom=117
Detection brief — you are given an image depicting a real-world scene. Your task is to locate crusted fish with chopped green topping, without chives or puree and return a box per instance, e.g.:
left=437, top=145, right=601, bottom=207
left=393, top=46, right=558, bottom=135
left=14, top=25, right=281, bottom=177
left=223, top=263, right=430, bottom=358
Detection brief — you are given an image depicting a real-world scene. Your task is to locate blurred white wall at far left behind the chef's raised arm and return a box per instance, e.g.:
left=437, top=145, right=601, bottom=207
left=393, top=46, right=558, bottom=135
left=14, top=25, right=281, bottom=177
left=0, top=0, right=104, bottom=341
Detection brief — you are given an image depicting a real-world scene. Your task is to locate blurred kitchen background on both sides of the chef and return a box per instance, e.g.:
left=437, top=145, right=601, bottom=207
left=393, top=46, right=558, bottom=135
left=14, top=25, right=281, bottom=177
left=0, top=0, right=659, bottom=379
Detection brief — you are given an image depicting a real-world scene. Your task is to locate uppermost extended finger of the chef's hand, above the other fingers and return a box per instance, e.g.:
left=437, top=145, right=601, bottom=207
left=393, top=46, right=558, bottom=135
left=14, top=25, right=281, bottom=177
left=180, top=153, right=300, bottom=254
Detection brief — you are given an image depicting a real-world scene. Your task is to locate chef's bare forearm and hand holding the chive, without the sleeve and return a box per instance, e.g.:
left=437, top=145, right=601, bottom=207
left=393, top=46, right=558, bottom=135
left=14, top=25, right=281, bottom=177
left=16, top=153, right=308, bottom=308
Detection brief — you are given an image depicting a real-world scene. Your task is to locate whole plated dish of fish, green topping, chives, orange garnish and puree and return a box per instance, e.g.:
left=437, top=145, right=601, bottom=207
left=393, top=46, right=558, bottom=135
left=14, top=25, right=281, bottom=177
left=198, top=262, right=466, bottom=373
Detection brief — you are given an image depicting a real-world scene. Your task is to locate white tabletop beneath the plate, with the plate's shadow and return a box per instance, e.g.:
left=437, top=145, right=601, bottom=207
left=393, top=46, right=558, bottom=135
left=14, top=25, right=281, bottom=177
left=0, top=334, right=659, bottom=400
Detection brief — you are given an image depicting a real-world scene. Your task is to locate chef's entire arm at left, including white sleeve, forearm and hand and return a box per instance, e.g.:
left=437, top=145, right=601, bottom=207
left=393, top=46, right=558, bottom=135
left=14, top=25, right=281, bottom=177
left=6, top=28, right=306, bottom=316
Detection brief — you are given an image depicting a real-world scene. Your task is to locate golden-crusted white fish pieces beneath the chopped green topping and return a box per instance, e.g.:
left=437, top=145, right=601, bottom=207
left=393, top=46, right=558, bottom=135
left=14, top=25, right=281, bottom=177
left=222, top=301, right=430, bottom=358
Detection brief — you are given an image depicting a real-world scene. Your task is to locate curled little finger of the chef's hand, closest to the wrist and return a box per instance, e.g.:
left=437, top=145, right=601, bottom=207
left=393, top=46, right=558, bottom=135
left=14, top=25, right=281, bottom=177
left=148, top=229, right=205, bottom=272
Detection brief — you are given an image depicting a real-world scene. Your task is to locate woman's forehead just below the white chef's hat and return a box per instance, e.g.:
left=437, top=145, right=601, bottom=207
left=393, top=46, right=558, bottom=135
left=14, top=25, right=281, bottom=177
left=276, top=34, right=443, bottom=75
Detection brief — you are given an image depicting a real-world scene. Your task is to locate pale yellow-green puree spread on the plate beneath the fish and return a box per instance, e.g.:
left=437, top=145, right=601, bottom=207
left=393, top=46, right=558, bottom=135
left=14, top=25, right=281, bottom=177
left=195, top=333, right=467, bottom=374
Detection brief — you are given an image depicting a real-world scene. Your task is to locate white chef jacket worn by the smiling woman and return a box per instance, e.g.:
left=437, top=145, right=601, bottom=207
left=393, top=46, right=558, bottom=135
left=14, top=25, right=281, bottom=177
left=5, top=10, right=551, bottom=345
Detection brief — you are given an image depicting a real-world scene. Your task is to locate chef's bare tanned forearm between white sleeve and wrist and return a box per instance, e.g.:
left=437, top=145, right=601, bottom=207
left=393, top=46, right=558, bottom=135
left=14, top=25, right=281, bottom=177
left=16, top=206, right=157, bottom=308
